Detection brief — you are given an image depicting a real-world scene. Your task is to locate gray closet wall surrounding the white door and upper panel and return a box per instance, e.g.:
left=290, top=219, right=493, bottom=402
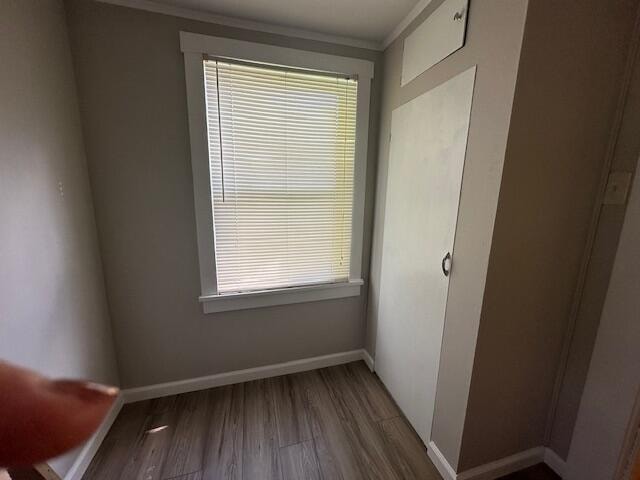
left=366, top=0, right=527, bottom=468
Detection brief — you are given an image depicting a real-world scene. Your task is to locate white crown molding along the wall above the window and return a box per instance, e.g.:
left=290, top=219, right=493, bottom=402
left=97, top=0, right=384, bottom=51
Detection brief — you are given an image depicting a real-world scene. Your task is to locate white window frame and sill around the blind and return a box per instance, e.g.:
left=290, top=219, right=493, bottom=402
left=180, top=32, right=373, bottom=313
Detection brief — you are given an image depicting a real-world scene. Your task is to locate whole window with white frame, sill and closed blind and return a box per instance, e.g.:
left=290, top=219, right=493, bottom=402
left=181, top=32, right=372, bottom=312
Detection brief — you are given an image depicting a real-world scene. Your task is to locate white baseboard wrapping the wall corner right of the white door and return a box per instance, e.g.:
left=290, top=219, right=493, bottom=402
left=427, top=442, right=564, bottom=480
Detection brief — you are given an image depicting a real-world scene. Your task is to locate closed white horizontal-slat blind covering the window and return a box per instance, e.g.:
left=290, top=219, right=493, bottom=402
left=204, top=59, right=357, bottom=294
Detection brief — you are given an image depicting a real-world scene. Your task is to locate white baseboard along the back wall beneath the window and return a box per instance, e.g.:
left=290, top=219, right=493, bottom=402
left=122, top=349, right=371, bottom=403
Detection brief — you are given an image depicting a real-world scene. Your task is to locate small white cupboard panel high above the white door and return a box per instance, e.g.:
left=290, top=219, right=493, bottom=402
left=400, top=0, right=469, bottom=85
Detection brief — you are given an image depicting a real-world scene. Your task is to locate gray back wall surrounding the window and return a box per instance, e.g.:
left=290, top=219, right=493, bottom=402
left=66, top=0, right=381, bottom=387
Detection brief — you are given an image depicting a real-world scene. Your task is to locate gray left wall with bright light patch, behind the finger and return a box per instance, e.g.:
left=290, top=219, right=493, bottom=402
left=0, top=0, right=118, bottom=474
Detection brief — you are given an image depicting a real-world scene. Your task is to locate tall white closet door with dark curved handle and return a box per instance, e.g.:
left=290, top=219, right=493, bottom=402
left=376, top=67, right=475, bottom=444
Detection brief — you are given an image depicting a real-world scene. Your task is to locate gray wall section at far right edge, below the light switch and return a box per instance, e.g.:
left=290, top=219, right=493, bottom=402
left=566, top=158, right=640, bottom=480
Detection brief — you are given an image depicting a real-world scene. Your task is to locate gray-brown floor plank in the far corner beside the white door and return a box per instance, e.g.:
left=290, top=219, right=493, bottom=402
left=344, top=361, right=400, bottom=422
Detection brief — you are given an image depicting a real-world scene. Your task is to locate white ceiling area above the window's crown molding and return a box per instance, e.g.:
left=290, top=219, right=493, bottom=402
left=148, top=0, right=419, bottom=44
